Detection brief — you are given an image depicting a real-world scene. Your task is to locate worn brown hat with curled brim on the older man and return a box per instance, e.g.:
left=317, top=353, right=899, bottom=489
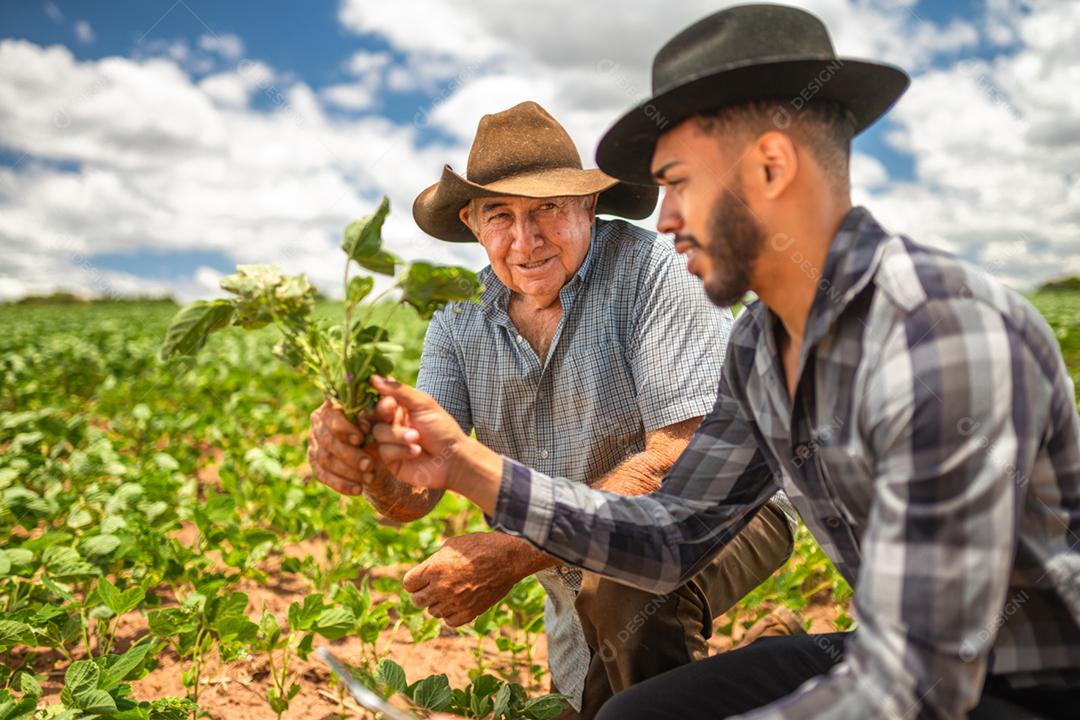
left=413, top=101, right=658, bottom=243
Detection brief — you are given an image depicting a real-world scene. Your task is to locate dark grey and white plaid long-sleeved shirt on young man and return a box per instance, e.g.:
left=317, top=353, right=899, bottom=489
left=492, top=208, right=1080, bottom=720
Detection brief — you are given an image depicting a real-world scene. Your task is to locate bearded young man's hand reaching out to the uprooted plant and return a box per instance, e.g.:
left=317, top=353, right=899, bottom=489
left=372, top=376, right=469, bottom=489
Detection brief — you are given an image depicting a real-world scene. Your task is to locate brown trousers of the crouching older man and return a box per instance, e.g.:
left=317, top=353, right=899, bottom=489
left=561, top=505, right=793, bottom=720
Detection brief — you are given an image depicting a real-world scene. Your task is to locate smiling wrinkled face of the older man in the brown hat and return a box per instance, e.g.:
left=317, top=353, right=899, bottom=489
left=461, top=196, right=595, bottom=298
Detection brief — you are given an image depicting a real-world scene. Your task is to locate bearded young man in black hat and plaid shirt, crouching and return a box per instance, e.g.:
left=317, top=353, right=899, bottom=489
left=360, top=5, right=1080, bottom=720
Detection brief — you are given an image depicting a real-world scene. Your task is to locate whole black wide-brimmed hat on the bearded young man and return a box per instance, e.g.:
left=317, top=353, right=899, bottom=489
left=596, top=4, right=910, bottom=185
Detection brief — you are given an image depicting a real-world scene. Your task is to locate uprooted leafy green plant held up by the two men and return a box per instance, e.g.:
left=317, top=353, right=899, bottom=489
left=161, top=198, right=482, bottom=419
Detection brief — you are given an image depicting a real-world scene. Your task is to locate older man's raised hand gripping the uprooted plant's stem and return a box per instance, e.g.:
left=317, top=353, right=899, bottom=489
left=308, top=400, right=375, bottom=495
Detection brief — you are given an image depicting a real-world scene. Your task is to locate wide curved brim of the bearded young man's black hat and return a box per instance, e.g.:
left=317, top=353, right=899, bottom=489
left=596, top=57, right=910, bottom=185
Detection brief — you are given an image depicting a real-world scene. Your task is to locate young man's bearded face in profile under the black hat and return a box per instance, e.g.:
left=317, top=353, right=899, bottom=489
left=652, top=121, right=766, bottom=307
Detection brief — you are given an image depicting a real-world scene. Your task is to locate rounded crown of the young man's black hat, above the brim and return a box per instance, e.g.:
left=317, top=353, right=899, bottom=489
left=652, top=4, right=836, bottom=95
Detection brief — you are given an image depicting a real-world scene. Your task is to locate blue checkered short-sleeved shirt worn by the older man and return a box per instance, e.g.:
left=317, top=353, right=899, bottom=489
left=417, top=220, right=732, bottom=705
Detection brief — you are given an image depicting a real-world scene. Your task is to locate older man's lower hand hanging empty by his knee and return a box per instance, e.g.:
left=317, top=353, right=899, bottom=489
left=402, top=532, right=534, bottom=627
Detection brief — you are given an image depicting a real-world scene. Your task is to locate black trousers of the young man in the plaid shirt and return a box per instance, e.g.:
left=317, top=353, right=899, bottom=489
left=597, top=633, right=1080, bottom=720
